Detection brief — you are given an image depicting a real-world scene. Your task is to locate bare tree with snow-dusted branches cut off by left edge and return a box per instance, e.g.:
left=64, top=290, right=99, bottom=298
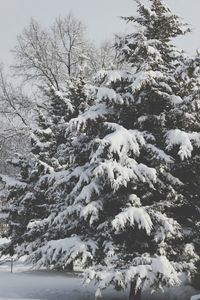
left=0, top=67, right=31, bottom=174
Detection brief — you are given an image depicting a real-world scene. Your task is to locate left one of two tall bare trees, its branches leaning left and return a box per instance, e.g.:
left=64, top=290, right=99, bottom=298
left=13, top=19, right=60, bottom=88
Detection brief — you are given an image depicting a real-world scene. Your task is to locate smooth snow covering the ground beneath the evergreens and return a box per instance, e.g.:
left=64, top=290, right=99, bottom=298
left=0, top=262, right=199, bottom=300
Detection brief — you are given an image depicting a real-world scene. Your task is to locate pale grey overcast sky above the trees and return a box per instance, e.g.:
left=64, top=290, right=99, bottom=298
left=0, top=0, right=200, bottom=64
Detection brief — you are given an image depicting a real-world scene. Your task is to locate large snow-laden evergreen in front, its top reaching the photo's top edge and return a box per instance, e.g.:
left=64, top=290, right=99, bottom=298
left=12, top=0, right=199, bottom=300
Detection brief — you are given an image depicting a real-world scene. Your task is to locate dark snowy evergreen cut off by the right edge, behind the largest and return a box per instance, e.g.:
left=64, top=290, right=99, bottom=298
left=173, top=51, right=200, bottom=288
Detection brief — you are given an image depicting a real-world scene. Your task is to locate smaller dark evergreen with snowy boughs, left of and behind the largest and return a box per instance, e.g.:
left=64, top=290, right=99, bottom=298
left=0, top=77, right=86, bottom=262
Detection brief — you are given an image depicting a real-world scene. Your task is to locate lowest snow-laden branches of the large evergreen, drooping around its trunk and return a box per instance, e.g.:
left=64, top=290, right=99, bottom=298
left=85, top=255, right=180, bottom=297
